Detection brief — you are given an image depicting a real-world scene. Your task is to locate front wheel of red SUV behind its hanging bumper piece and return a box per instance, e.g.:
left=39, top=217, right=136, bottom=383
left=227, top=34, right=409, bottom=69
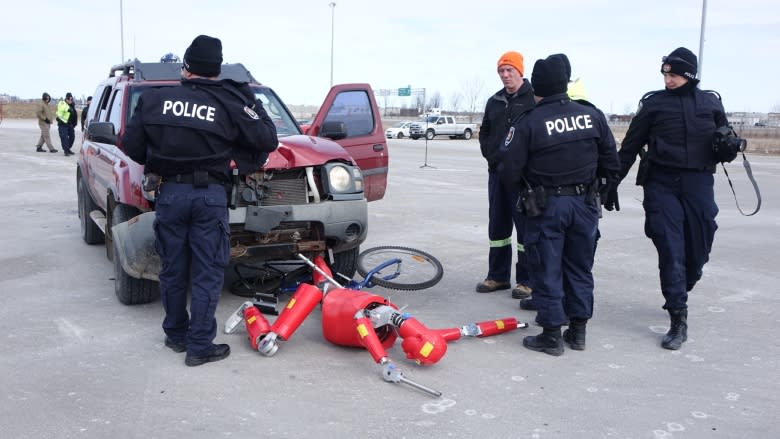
left=111, top=204, right=160, bottom=305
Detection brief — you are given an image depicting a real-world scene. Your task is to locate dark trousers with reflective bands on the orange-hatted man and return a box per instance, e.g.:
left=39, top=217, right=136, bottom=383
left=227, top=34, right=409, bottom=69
left=487, top=171, right=529, bottom=286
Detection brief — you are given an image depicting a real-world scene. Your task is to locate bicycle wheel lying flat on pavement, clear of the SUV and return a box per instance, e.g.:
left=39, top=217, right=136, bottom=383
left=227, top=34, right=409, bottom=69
left=357, top=245, right=444, bottom=291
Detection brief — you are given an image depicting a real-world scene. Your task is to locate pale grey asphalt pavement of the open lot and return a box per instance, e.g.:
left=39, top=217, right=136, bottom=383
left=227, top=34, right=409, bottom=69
left=0, top=119, right=780, bottom=439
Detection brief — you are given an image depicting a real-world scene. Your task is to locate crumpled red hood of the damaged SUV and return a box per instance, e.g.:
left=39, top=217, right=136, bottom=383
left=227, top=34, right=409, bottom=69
left=264, top=135, right=355, bottom=169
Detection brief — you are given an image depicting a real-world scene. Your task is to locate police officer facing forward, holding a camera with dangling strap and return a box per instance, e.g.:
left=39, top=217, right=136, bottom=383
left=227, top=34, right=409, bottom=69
left=605, top=47, right=728, bottom=349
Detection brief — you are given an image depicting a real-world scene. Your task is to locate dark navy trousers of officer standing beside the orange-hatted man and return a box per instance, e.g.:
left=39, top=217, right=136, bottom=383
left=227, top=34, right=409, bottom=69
left=524, top=195, right=599, bottom=328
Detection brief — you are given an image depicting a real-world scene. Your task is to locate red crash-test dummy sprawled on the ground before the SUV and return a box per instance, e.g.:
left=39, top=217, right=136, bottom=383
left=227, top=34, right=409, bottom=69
left=225, top=254, right=528, bottom=397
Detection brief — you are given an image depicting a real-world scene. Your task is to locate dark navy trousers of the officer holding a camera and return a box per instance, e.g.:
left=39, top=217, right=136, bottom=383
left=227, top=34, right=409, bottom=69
left=643, top=167, right=718, bottom=309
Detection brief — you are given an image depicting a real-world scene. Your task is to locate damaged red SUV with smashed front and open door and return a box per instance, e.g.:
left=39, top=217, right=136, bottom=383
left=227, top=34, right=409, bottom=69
left=76, top=60, right=388, bottom=305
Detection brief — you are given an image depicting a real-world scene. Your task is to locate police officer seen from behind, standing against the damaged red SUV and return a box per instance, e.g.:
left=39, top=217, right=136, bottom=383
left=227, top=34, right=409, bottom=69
left=122, top=35, right=278, bottom=366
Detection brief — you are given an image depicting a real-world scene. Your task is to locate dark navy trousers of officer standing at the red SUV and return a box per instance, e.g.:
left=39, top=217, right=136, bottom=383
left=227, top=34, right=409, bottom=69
left=154, top=183, right=230, bottom=355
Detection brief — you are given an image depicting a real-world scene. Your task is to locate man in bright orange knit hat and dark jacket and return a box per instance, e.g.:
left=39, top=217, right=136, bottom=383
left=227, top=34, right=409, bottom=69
left=476, top=51, right=534, bottom=299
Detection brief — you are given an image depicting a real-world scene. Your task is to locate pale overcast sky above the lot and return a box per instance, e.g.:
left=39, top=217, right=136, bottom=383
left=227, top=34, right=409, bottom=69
left=0, top=0, right=780, bottom=113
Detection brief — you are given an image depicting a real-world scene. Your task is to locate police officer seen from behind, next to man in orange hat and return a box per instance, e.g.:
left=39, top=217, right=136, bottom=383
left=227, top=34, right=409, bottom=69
left=506, top=55, right=619, bottom=355
